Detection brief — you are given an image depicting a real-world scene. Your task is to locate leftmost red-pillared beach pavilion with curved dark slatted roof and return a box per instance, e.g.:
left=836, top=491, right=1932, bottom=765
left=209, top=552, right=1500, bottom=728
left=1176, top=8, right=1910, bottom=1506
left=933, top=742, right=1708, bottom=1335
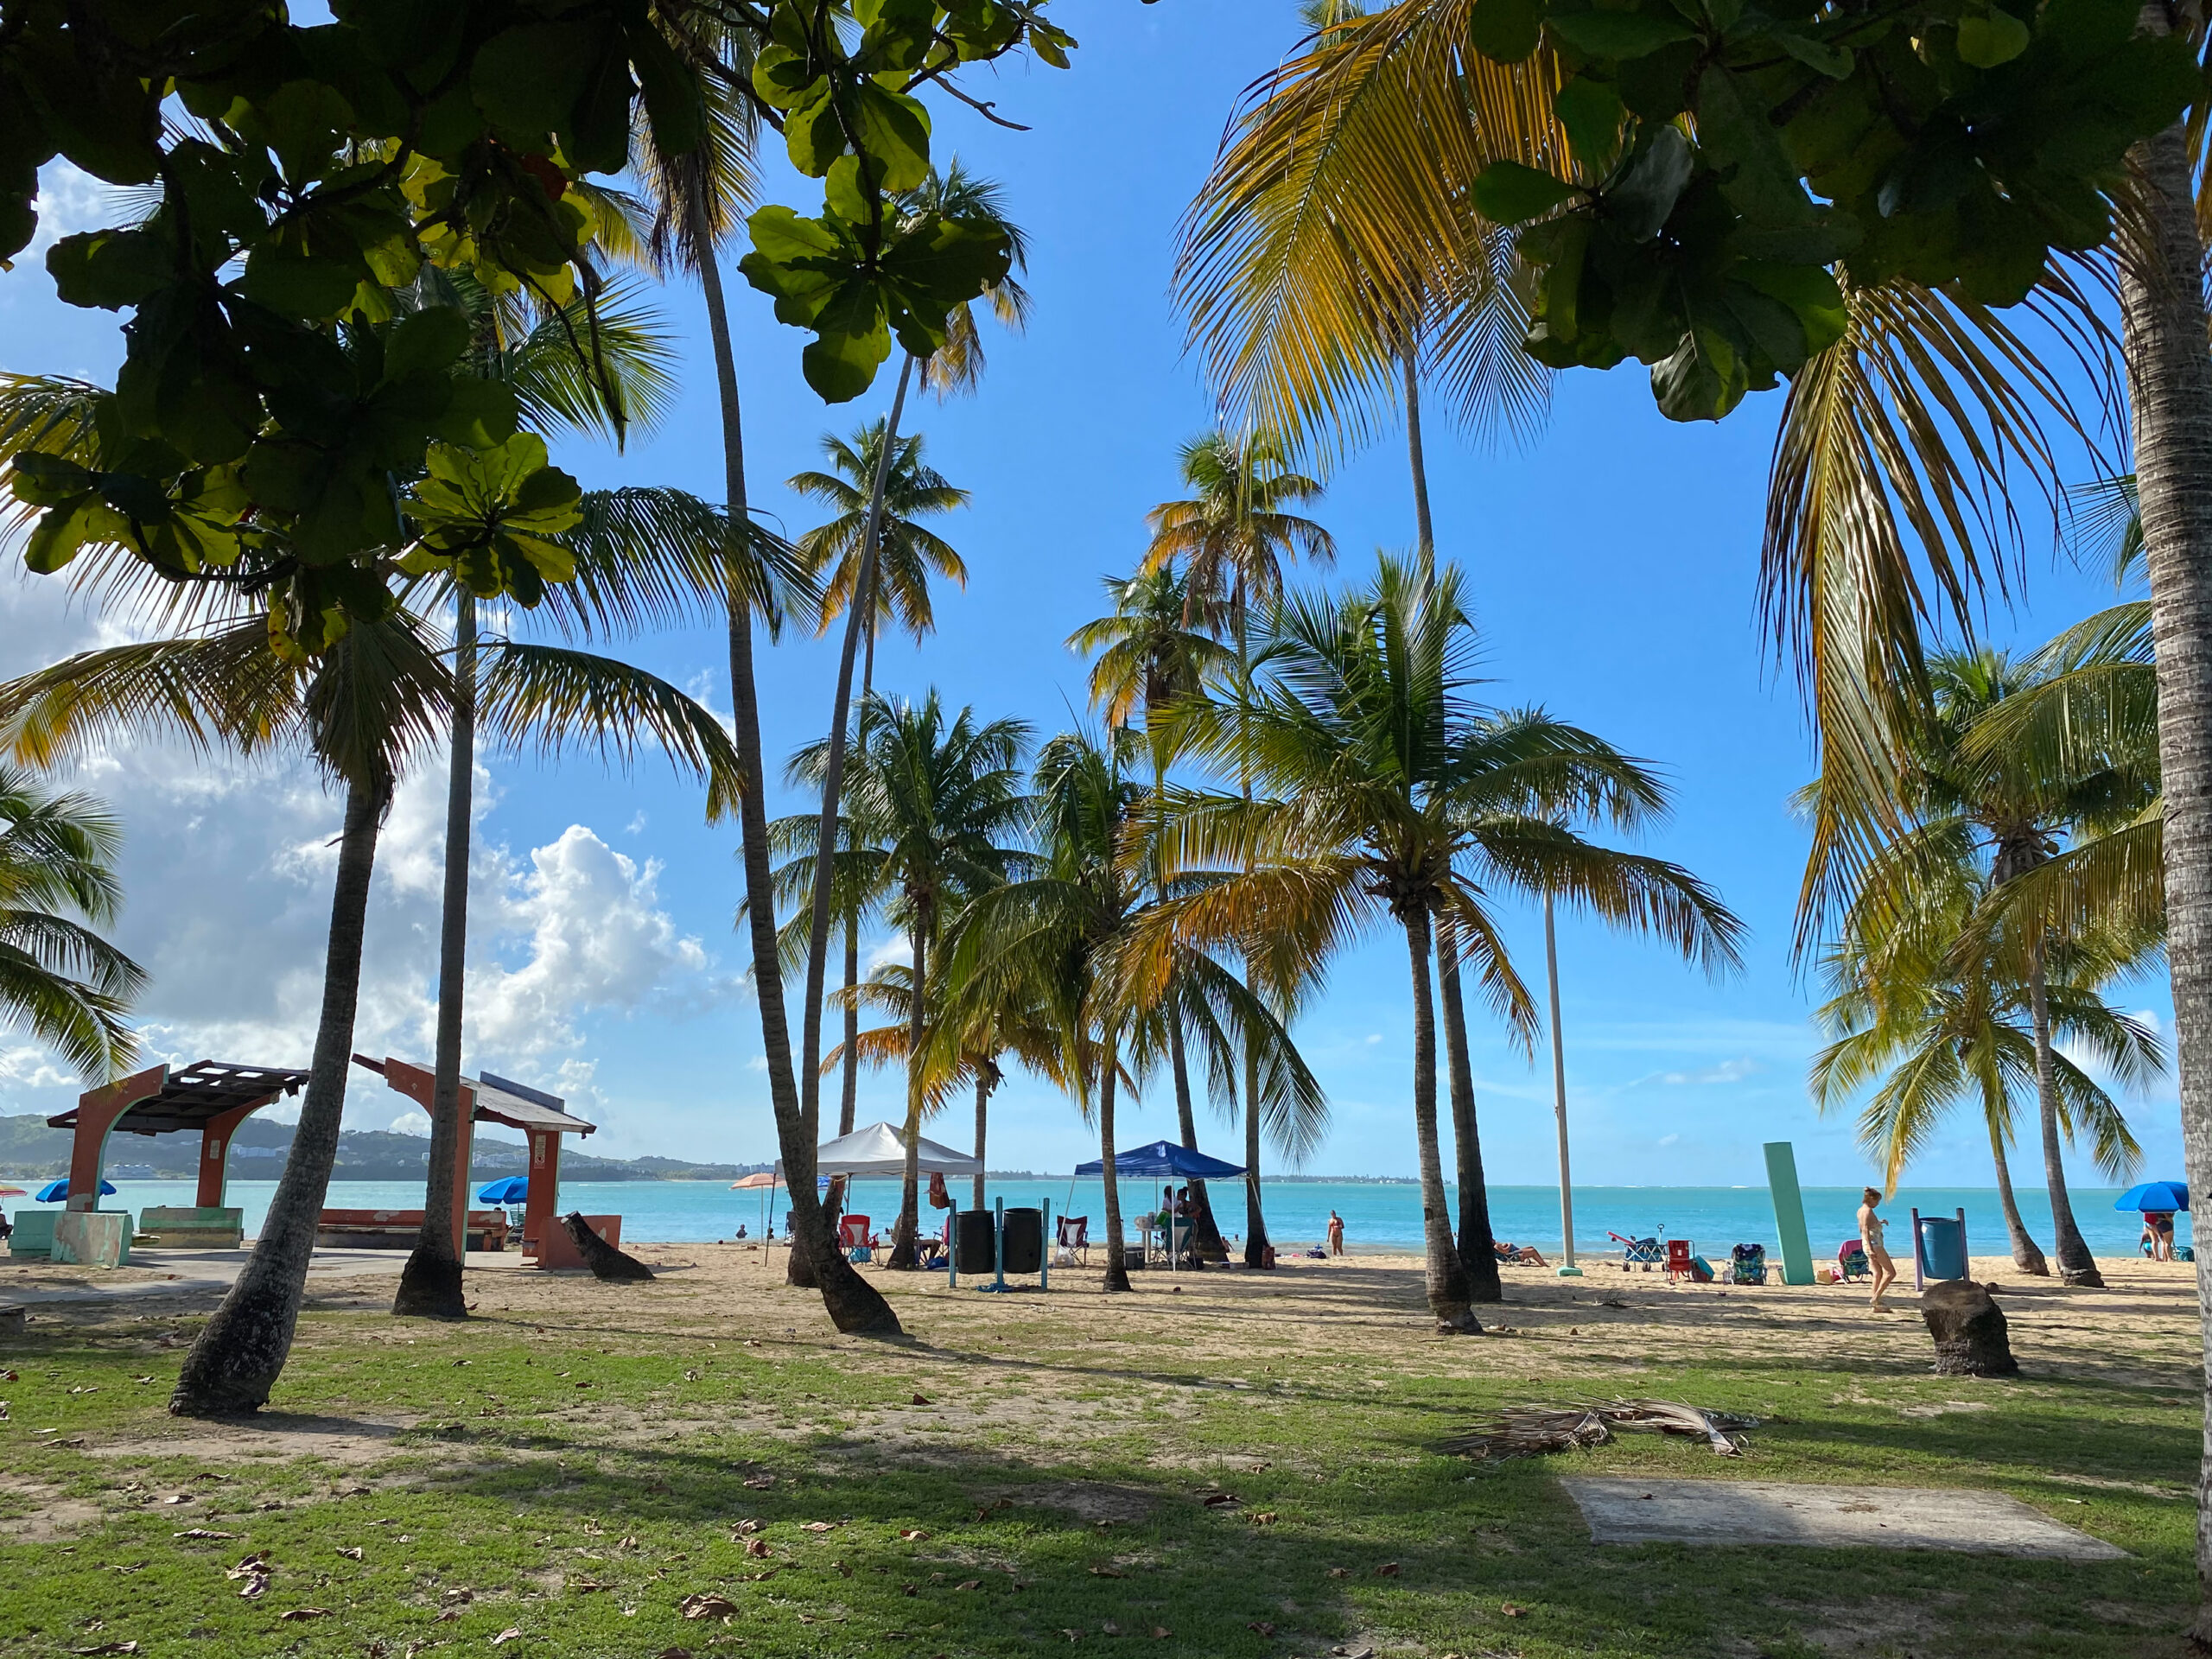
left=35, top=1059, right=308, bottom=1261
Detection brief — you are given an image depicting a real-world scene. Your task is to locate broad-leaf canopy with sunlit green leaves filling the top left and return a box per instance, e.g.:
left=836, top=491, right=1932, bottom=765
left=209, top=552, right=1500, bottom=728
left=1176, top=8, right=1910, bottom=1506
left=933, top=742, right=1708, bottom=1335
left=0, top=0, right=1073, bottom=659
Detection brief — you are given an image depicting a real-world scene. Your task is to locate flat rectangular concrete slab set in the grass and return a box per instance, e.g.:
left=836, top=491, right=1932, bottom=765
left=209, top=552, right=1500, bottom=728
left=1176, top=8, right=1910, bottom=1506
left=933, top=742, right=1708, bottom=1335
left=1560, top=1478, right=2128, bottom=1561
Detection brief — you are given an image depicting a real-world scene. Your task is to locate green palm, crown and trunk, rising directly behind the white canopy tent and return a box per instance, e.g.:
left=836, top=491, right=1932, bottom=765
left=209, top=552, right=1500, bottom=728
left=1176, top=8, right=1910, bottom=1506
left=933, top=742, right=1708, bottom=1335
left=849, top=692, right=1031, bottom=1268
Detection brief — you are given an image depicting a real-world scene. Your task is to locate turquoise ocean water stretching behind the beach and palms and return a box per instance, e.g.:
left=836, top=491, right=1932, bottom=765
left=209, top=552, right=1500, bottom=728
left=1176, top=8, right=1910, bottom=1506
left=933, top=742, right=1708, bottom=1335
left=39, top=1179, right=2190, bottom=1259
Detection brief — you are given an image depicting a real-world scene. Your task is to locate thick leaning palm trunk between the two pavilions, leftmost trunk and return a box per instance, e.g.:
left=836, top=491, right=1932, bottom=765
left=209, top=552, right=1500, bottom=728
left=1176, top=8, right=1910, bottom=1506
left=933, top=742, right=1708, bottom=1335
left=168, top=783, right=391, bottom=1418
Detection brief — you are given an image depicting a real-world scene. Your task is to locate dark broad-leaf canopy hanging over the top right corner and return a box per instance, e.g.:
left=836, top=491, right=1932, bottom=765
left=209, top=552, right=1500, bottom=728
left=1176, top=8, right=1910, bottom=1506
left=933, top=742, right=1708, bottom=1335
left=1466, top=0, right=2199, bottom=420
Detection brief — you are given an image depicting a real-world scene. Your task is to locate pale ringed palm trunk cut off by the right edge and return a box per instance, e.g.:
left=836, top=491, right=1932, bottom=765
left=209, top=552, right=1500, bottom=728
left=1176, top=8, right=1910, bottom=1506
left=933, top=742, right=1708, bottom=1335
left=2119, top=52, right=2212, bottom=1648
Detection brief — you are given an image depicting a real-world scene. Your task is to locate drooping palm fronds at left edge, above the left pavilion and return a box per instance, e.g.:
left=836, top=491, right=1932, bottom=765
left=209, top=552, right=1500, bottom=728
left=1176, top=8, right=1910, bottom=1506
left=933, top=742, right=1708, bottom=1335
left=0, top=763, right=146, bottom=1082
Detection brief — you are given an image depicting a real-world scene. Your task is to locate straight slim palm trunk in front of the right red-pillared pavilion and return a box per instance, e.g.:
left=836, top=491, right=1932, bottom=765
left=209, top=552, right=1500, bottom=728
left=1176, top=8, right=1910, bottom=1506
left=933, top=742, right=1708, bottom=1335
left=391, top=588, right=482, bottom=1319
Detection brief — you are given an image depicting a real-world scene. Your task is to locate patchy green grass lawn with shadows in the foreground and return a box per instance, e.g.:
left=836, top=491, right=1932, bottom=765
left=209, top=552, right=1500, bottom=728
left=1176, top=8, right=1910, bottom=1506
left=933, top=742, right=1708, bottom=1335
left=0, top=1276, right=2199, bottom=1659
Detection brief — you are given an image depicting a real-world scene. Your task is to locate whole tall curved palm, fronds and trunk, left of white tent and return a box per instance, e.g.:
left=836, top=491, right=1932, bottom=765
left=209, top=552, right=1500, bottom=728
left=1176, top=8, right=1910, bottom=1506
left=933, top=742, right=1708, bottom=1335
left=632, top=13, right=900, bottom=1334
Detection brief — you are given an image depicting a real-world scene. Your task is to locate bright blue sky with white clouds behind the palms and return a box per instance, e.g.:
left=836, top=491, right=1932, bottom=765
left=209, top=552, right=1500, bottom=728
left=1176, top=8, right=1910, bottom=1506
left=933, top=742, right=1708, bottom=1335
left=0, top=0, right=2179, bottom=1185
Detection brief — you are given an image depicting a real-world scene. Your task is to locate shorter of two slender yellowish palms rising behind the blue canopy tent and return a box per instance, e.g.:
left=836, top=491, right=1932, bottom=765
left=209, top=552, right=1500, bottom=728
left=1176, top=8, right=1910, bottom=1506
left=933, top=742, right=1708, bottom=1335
left=1068, top=562, right=1236, bottom=1261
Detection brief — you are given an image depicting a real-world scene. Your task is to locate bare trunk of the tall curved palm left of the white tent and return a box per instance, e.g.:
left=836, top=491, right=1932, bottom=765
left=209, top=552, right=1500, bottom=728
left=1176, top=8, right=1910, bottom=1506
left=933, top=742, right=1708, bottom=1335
left=692, top=199, right=900, bottom=1336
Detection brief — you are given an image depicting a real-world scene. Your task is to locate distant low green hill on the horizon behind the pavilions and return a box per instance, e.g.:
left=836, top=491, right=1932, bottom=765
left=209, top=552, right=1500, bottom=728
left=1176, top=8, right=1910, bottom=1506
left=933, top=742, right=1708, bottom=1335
left=0, top=1113, right=767, bottom=1181
